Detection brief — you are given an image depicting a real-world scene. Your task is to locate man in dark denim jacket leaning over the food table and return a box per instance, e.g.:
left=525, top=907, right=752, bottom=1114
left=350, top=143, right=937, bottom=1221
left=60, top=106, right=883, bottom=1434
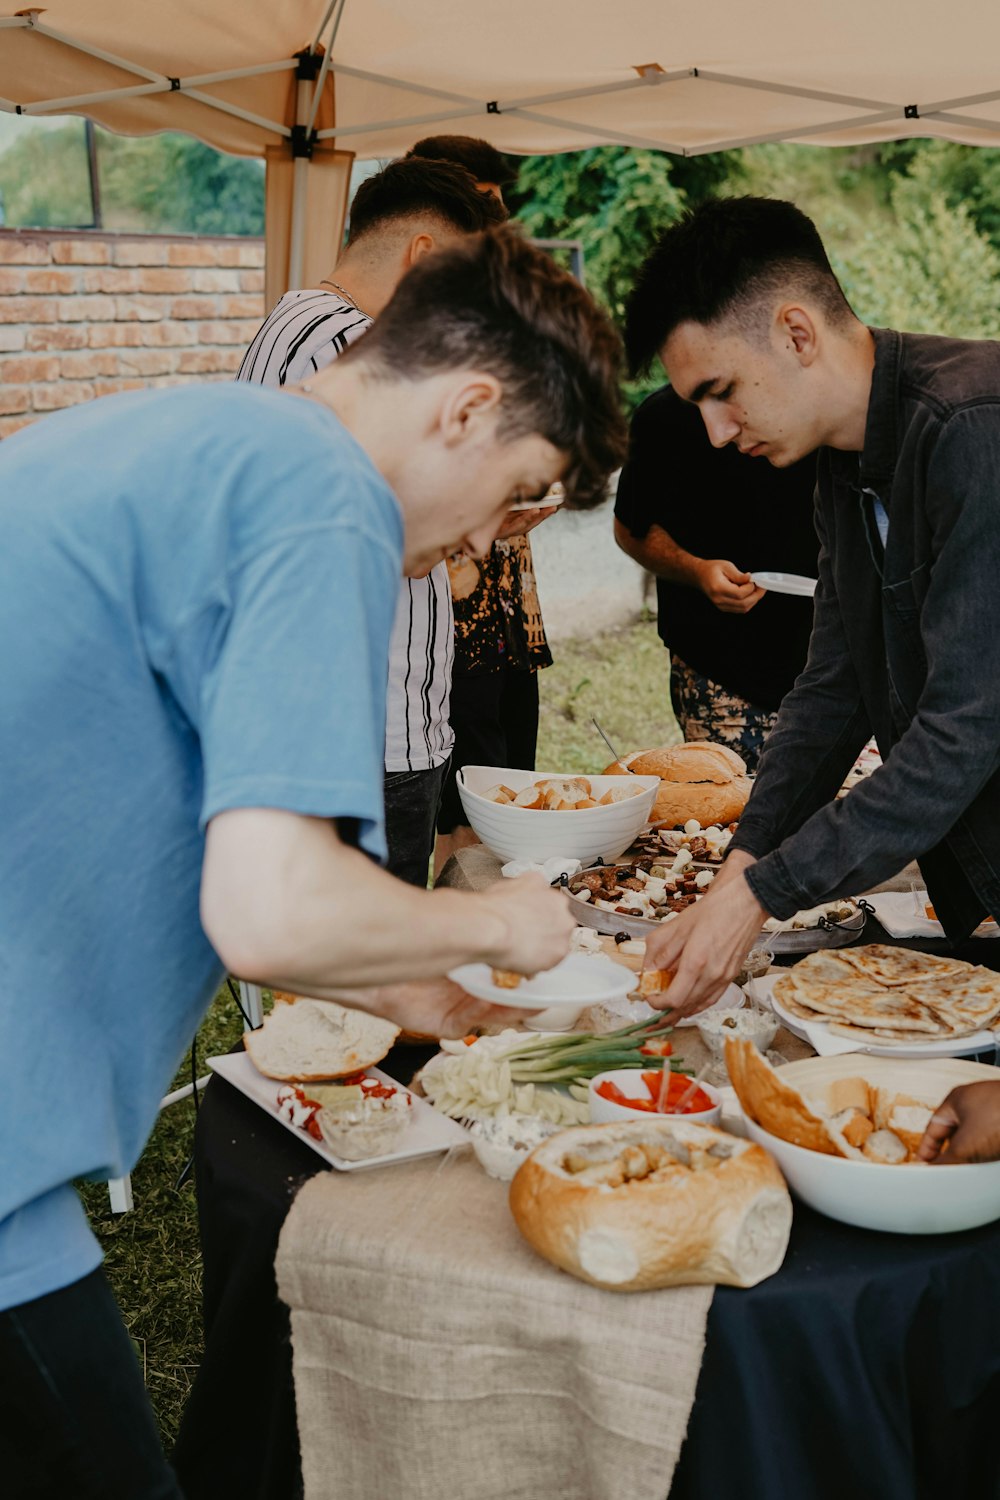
left=628, top=198, right=1000, bottom=1068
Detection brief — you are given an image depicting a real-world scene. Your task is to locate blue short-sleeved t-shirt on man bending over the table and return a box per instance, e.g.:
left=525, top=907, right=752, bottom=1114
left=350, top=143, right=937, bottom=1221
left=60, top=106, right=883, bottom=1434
left=0, top=386, right=402, bottom=1308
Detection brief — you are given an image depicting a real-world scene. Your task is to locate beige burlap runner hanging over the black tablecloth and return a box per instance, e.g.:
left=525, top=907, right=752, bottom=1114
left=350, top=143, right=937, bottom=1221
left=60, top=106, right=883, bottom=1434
left=276, top=1148, right=714, bottom=1500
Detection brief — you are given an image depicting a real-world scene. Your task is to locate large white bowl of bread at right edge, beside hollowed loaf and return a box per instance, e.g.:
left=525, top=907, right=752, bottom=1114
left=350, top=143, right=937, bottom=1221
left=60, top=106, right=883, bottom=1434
left=747, top=1053, right=1000, bottom=1235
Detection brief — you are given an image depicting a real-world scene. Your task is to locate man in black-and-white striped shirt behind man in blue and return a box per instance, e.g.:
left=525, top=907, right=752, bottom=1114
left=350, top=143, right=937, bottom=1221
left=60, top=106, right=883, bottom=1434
left=237, top=159, right=505, bottom=885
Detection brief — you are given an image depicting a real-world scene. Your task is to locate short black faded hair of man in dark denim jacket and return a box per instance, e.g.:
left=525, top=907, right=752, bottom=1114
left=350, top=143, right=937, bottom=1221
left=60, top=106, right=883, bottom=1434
left=625, top=198, right=852, bottom=374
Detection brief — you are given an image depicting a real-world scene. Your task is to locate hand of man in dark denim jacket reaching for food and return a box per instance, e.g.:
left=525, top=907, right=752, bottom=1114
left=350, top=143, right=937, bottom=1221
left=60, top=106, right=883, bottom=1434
left=643, top=849, right=768, bottom=1016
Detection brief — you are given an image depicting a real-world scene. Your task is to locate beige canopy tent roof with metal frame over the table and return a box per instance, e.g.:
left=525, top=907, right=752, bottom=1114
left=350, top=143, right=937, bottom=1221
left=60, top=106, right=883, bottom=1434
left=0, top=0, right=1000, bottom=300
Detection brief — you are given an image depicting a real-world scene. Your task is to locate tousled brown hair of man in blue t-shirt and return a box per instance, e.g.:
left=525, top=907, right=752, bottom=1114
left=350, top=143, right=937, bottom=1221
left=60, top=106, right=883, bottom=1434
left=353, top=225, right=628, bottom=507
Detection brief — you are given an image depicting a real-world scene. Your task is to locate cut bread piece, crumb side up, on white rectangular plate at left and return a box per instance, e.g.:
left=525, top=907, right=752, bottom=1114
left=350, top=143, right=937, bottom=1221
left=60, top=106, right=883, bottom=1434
left=243, top=1001, right=399, bottom=1083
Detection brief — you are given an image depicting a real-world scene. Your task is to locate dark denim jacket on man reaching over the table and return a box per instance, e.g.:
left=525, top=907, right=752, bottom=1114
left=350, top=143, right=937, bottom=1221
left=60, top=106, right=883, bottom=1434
left=733, top=329, right=1000, bottom=939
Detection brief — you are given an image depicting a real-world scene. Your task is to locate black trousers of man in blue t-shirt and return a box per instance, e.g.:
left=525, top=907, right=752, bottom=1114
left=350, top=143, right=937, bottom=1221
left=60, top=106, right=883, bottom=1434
left=0, top=1271, right=181, bottom=1500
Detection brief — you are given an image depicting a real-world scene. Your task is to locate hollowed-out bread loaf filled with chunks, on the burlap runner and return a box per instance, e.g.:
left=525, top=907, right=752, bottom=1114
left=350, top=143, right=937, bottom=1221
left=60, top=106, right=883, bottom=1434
left=510, top=1119, right=792, bottom=1292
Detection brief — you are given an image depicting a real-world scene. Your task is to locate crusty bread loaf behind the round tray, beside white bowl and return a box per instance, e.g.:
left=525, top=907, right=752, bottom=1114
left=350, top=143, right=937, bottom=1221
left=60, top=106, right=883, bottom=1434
left=603, top=740, right=750, bottom=828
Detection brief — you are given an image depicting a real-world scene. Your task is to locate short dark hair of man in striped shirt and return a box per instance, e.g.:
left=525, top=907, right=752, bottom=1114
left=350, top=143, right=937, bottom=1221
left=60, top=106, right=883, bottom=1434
left=348, top=158, right=507, bottom=245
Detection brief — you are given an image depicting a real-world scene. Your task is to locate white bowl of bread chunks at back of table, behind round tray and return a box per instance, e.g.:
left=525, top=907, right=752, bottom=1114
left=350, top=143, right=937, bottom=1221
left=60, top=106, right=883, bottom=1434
left=457, top=765, right=660, bottom=866
